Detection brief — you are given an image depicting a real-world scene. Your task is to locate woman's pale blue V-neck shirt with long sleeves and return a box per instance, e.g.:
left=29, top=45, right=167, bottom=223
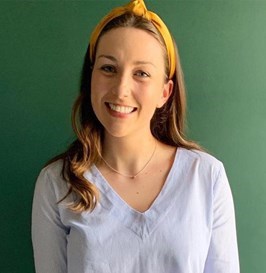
left=32, top=148, right=239, bottom=273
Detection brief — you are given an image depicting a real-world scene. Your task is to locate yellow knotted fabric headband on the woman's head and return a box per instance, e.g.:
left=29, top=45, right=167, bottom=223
left=90, top=0, right=176, bottom=79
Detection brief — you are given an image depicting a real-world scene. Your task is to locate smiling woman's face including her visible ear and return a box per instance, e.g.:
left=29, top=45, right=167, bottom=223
left=91, top=27, right=173, bottom=137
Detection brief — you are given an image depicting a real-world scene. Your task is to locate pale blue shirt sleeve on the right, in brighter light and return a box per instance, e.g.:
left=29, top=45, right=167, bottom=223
left=204, top=166, right=240, bottom=273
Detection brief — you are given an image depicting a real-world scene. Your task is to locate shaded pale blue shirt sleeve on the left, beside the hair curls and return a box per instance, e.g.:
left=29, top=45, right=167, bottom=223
left=32, top=166, right=68, bottom=273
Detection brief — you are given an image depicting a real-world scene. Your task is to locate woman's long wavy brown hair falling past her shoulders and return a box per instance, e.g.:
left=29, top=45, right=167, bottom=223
left=48, top=12, right=201, bottom=212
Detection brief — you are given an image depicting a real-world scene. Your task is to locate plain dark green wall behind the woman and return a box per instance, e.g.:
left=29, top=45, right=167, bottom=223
left=0, top=0, right=266, bottom=273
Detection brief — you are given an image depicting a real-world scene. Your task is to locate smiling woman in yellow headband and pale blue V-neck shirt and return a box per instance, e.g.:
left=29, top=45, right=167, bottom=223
left=32, top=1, right=239, bottom=273
